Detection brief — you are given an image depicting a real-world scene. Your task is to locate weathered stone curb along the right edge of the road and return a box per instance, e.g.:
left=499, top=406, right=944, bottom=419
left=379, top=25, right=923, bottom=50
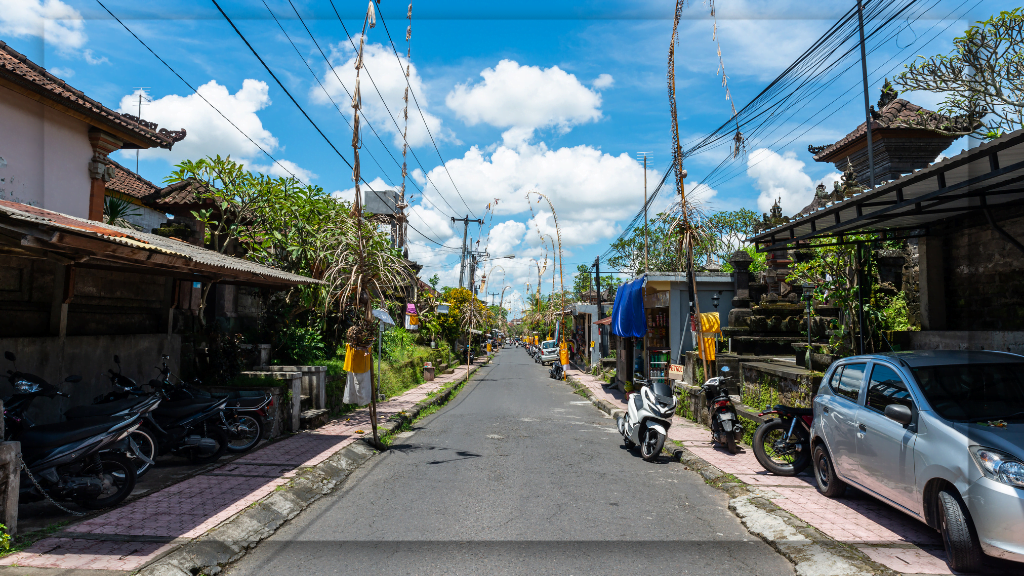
left=566, top=377, right=899, bottom=576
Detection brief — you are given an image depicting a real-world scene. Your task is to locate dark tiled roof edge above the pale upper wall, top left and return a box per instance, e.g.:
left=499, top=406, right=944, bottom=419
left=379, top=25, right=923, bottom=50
left=0, top=41, right=185, bottom=150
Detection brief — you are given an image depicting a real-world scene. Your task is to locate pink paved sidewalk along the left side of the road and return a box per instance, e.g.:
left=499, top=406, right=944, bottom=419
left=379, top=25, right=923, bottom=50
left=0, top=358, right=487, bottom=571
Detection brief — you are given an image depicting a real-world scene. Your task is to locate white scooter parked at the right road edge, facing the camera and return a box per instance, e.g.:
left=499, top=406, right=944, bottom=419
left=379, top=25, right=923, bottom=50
left=617, top=377, right=676, bottom=462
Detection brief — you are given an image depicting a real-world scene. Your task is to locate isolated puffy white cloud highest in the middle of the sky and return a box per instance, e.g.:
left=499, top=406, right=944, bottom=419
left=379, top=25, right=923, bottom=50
left=444, top=59, right=611, bottom=132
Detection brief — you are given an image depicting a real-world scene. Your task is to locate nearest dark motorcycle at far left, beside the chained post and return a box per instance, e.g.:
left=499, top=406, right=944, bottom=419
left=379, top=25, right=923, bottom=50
left=4, top=352, right=139, bottom=509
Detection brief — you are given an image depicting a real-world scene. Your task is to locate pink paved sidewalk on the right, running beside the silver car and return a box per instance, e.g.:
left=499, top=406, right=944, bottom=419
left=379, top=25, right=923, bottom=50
left=568, top=369, right=952, bottom=574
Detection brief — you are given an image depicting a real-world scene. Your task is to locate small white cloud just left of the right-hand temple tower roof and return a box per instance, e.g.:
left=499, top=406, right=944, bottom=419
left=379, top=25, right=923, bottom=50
left=746, top=148, right=839, bottom=215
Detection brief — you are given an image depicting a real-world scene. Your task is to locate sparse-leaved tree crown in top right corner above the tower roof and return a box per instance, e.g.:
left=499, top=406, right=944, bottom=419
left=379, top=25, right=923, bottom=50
left=895, top=8, right=1024, bottom=139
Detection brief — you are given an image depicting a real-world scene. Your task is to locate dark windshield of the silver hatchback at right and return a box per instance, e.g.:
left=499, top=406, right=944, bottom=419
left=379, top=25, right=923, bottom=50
left=912, top=363, right=1024, bottom=422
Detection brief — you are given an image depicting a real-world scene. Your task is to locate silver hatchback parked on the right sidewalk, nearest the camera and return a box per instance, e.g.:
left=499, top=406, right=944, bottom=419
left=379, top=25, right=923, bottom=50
left=811, top=351, right=1024, bottom=572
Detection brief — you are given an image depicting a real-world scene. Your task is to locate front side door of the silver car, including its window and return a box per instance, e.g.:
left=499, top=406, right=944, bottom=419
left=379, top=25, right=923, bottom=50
left=856, top=364, right=921, bottom=513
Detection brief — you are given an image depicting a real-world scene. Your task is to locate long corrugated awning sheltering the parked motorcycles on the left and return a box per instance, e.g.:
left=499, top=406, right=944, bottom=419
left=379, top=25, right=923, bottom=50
left=0, top=200, right=323, bottom=289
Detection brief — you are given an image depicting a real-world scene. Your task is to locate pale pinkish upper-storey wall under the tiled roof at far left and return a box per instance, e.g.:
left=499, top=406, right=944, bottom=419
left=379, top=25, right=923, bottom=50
left=0, top=88, right=92, bottom=218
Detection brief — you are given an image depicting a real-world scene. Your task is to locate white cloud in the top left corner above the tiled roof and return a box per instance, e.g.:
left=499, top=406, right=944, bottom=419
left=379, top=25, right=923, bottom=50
left=0, top=0, right=85, bottom=53
